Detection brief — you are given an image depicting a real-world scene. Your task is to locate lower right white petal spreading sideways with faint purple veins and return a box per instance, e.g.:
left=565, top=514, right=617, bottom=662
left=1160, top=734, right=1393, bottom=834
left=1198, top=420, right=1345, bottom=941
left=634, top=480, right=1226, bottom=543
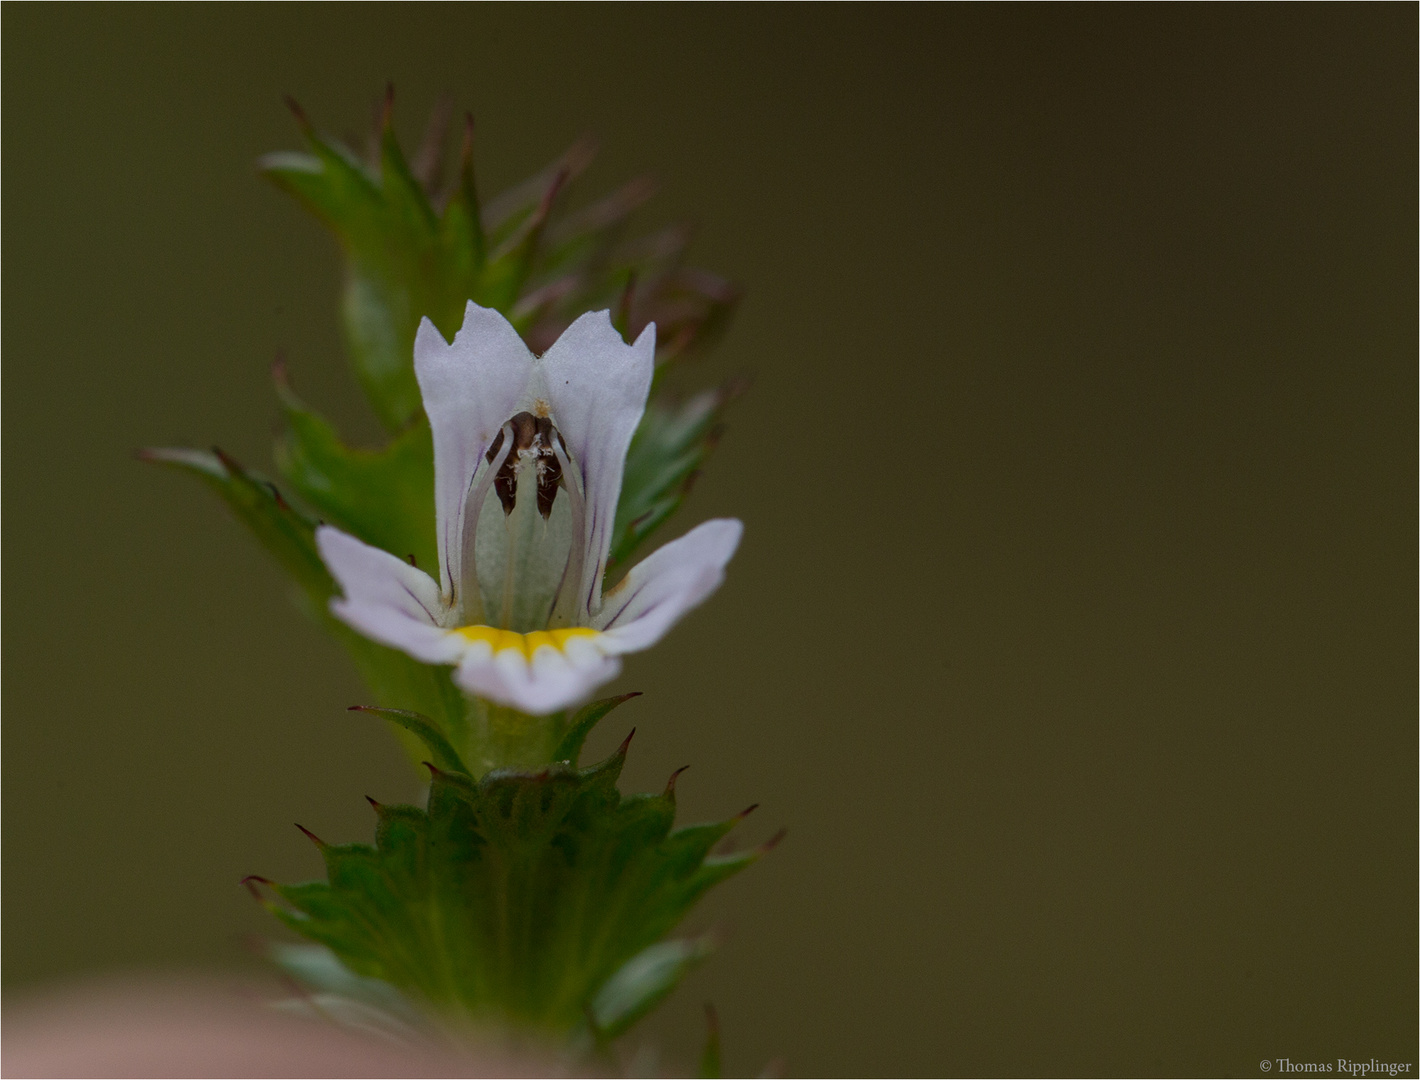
left=594, top=518, right=744, bottom=653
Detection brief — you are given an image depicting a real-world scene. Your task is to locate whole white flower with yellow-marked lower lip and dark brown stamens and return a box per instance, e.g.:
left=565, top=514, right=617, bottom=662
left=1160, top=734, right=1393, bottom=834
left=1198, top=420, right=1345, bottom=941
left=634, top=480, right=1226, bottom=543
left=315, top=302, right=743, bottom=714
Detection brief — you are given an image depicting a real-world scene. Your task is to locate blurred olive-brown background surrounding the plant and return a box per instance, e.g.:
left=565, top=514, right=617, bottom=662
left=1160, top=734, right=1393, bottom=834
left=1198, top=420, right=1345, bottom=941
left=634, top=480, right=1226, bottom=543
left=3, top=4, right=1417, bottom=1076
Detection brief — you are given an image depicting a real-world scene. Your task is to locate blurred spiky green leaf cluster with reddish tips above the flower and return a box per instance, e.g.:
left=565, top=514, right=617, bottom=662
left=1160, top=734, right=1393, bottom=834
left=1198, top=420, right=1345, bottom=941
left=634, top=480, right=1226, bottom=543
left=261, top=95, right=738, bottom=431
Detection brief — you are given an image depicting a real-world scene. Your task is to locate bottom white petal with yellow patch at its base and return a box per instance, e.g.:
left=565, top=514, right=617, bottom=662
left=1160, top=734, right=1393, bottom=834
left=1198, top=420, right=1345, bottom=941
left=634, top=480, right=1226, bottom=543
left=454, top=639, right=621, bottom=715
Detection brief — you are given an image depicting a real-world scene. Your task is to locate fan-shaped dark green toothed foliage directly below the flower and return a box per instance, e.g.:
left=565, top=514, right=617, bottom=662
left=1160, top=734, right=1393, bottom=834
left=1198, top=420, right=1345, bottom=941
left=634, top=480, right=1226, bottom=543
left=249, top=723, right=768, bottom=1042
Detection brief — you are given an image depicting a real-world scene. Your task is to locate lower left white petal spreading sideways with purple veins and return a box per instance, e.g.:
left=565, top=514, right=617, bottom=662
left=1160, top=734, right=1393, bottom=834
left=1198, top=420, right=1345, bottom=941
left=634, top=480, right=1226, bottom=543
left=315, top=525, right=464, bottom=664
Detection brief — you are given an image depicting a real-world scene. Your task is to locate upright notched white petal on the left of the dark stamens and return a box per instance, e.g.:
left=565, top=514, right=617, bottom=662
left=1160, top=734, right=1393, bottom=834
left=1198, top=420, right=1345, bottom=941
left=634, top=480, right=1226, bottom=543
left=415, top=301, right=534, bottom=596
